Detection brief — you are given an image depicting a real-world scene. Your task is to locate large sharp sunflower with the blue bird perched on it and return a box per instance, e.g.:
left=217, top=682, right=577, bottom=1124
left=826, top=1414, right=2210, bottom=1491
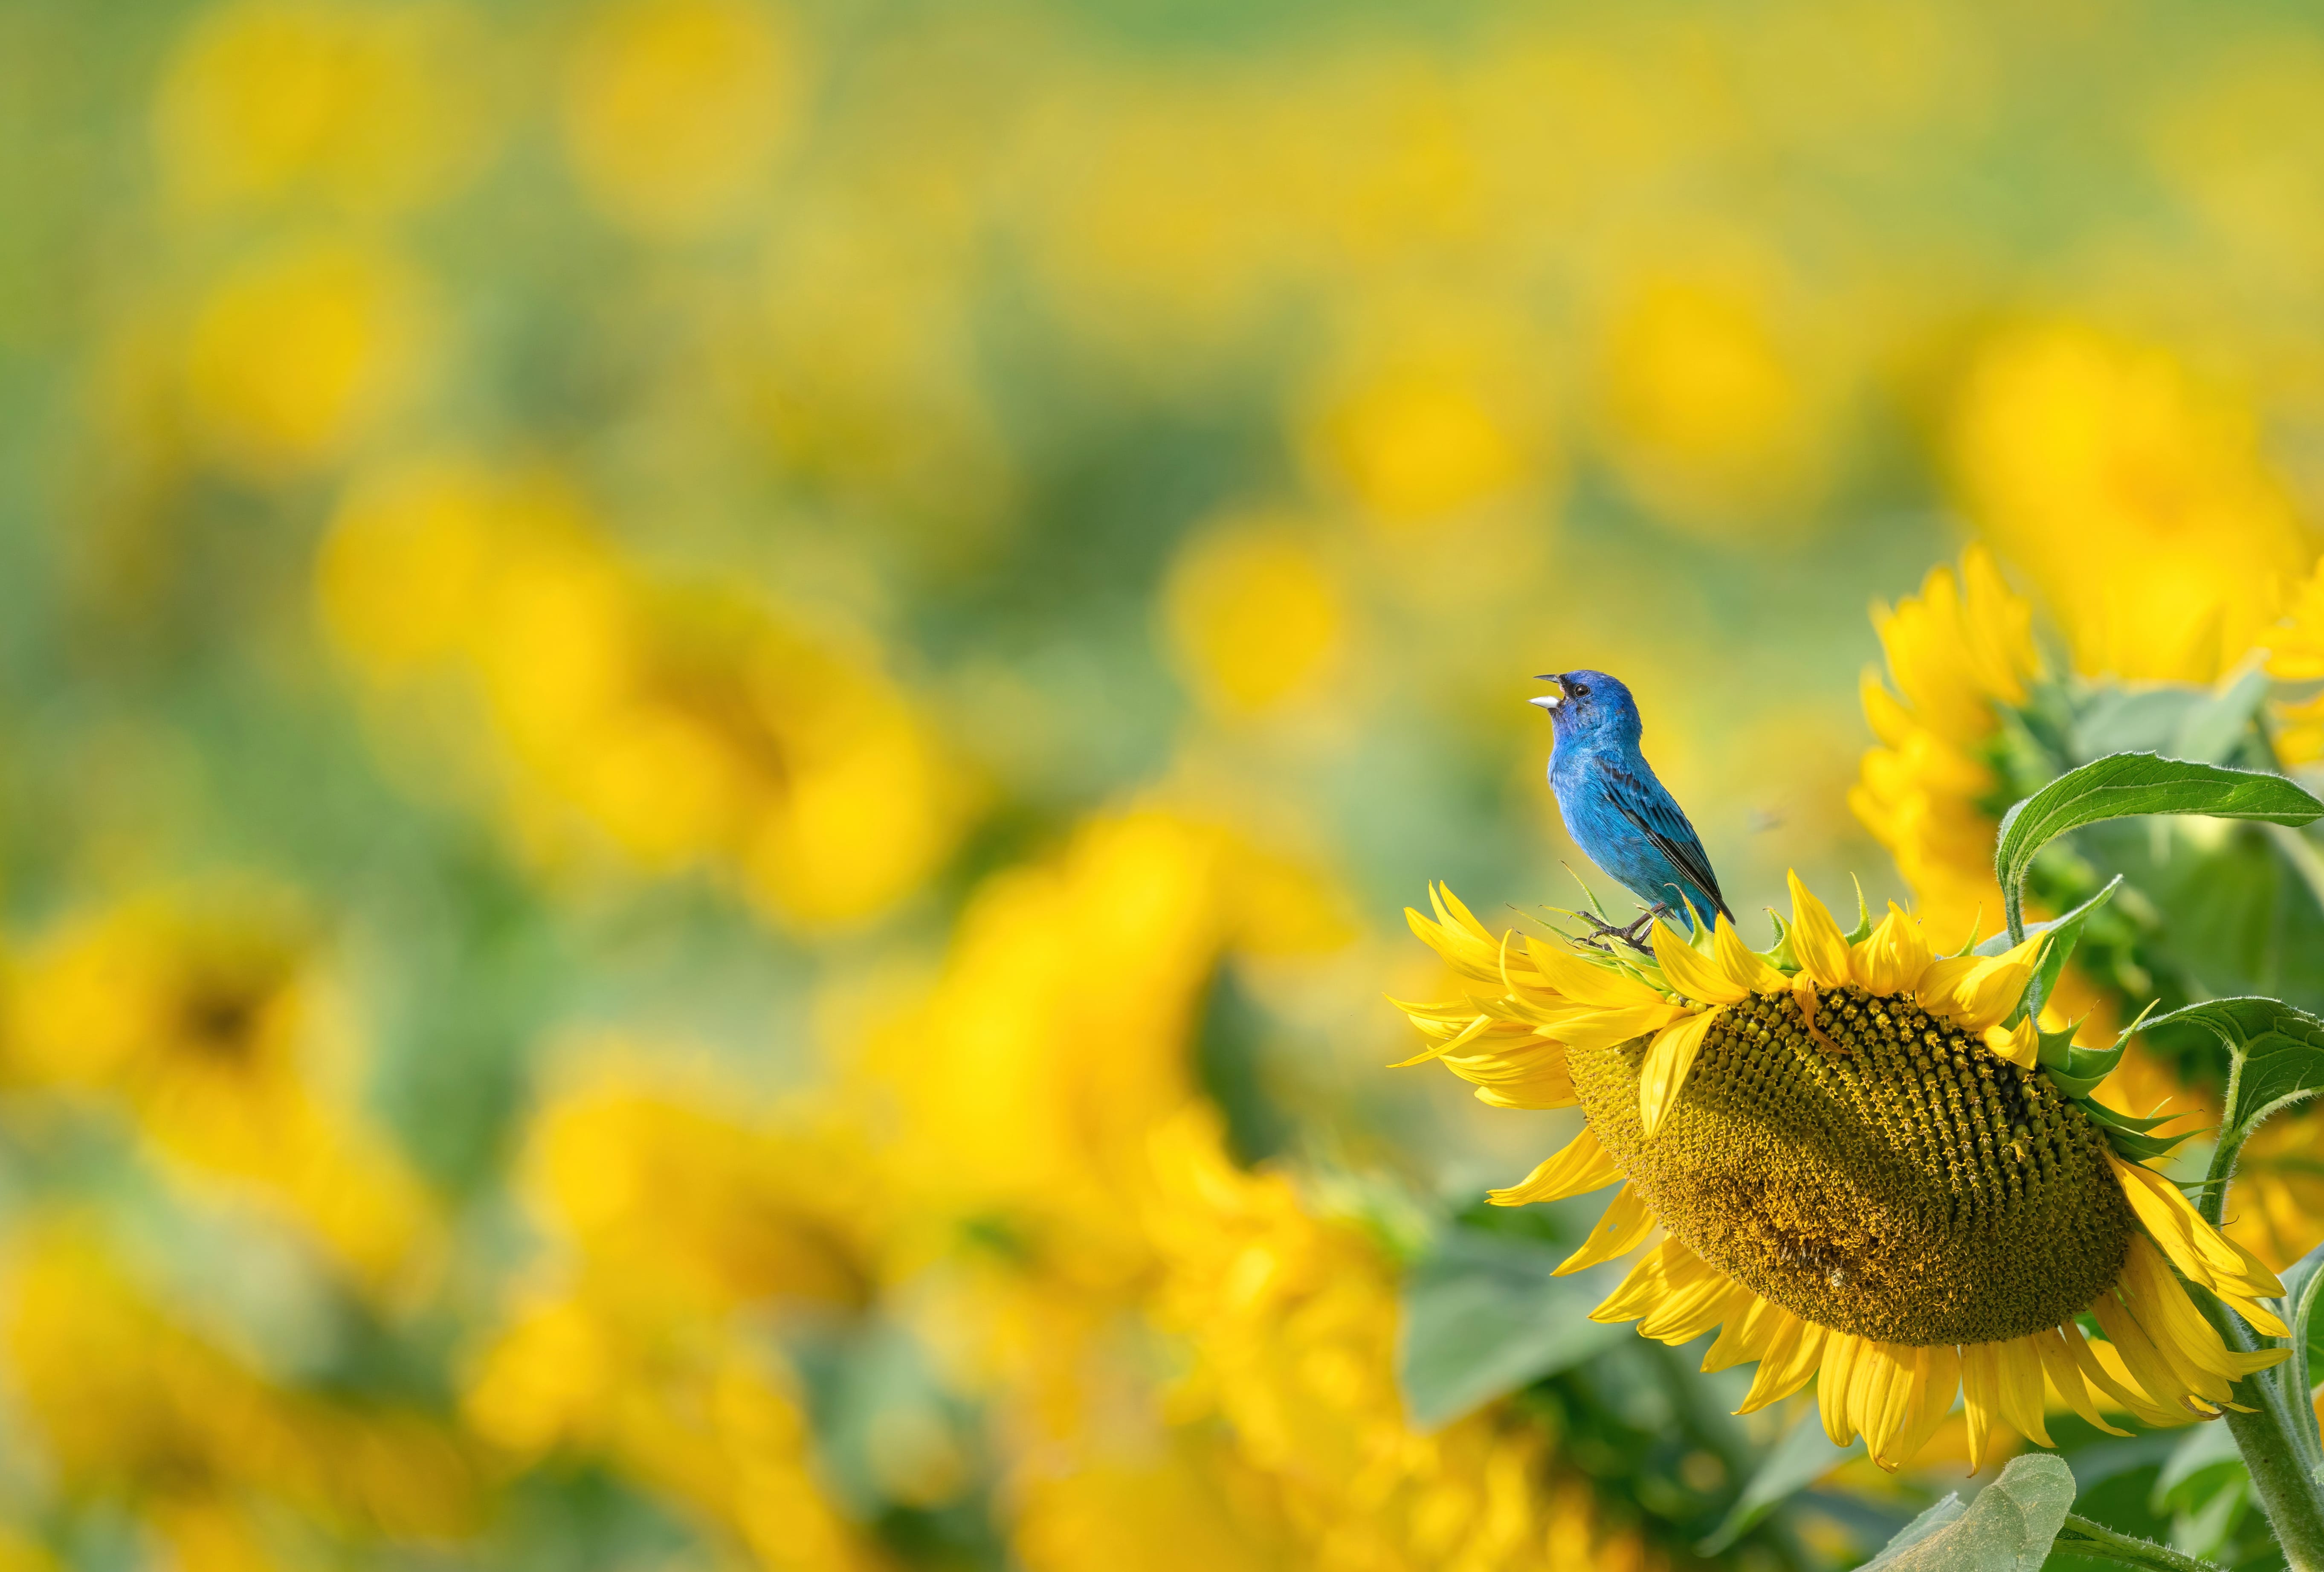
left=1401, top=874, right=2284, bottom=1470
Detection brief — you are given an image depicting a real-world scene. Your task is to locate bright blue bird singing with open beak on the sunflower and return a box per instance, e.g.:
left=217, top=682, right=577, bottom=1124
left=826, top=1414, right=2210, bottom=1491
left=1529, top=672, right=1734, bottom=944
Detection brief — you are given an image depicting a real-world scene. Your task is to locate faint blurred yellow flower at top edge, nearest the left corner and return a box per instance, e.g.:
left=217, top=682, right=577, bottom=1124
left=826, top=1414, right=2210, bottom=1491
left=154, top=0, right=488, bottom=209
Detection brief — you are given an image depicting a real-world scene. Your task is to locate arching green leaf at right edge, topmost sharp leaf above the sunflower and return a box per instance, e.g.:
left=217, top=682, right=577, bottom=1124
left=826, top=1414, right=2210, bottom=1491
left=1994, top=754, right=2324, bottom=942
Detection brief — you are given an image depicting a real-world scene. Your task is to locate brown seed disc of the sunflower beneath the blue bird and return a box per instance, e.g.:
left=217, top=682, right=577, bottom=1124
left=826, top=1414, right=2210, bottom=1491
left=1566, top=983, right=2131, bottom=1344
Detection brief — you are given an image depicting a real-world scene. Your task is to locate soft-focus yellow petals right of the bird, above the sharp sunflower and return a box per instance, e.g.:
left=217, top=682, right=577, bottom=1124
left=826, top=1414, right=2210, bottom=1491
left=1848, top=546, right=2040, bottom=949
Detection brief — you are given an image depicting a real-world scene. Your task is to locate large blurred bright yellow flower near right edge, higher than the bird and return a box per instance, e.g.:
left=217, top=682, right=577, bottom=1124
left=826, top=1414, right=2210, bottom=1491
left=1952, top=325, right=2317, bottom=682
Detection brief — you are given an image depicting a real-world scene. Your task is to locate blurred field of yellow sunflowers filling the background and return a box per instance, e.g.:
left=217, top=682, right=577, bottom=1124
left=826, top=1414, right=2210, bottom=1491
left=0, top=0, right=2324, bottom=1572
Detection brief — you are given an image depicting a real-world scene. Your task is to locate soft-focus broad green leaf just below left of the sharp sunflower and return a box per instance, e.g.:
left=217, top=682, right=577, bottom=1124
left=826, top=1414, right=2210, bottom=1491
left=1397, top=1228, right=1634, bottom=1430
